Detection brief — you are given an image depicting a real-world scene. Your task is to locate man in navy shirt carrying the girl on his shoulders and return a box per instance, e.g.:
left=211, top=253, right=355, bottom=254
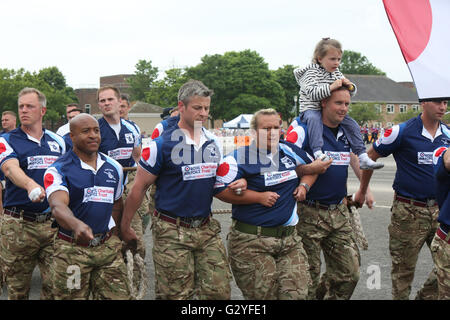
left=286, top=87, right=359, bottom=299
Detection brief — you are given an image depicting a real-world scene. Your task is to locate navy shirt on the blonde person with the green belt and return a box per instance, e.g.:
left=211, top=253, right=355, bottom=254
left=215, top=141, right=311, bottom=227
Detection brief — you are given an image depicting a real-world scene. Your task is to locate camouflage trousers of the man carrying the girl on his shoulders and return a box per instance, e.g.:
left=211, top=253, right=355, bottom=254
left=297, top=203, right=361, bottom=300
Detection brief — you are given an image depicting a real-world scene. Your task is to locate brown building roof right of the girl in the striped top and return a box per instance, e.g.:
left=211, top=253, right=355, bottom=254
left=345, top=74, right=419, bottom=103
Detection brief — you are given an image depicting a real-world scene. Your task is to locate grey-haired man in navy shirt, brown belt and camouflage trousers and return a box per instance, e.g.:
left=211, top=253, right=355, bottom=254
left=121, top=80, right=245, bottom=300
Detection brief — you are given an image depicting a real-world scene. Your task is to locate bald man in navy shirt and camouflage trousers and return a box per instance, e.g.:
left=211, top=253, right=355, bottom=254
left=44, top=114, right=130, bottom=300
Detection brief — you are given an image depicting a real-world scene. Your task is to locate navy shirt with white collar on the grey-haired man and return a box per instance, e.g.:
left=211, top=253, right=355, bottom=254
left=139, top=124, right=222, bottom=217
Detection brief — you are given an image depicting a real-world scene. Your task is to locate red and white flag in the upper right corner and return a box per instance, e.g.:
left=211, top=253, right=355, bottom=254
left=383, top=0, right=450, bottom=101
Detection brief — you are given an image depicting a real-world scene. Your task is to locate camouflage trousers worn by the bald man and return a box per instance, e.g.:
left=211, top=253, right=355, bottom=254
left=51, top=235, right=131, bottom=300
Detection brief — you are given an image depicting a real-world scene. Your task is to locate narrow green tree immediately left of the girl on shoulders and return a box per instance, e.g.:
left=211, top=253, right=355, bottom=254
left=273, top=65, right=300, bottom=123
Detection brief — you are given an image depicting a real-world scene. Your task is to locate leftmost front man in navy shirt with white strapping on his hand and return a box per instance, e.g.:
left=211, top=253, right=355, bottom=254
left=0, top=88, right=66, bottom=300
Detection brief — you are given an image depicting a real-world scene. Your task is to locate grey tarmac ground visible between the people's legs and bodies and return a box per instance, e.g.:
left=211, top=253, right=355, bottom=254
left=0, top=156, right=433, bottom=300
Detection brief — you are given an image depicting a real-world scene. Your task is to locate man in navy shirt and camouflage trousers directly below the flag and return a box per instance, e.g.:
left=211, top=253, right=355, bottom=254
left=355, top=100, right=450, bottom=300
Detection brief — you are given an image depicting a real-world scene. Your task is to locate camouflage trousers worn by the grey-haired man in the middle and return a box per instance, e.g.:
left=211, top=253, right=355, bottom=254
left=151, top=216, right=231, bottom=300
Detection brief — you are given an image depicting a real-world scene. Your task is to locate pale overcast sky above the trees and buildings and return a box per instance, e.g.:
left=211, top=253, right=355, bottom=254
left=0, top=0, right=411, bottom=89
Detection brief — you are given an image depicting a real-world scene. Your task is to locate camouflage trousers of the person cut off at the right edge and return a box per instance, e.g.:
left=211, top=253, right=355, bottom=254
left=430, top=230, right=450, bottom=300
